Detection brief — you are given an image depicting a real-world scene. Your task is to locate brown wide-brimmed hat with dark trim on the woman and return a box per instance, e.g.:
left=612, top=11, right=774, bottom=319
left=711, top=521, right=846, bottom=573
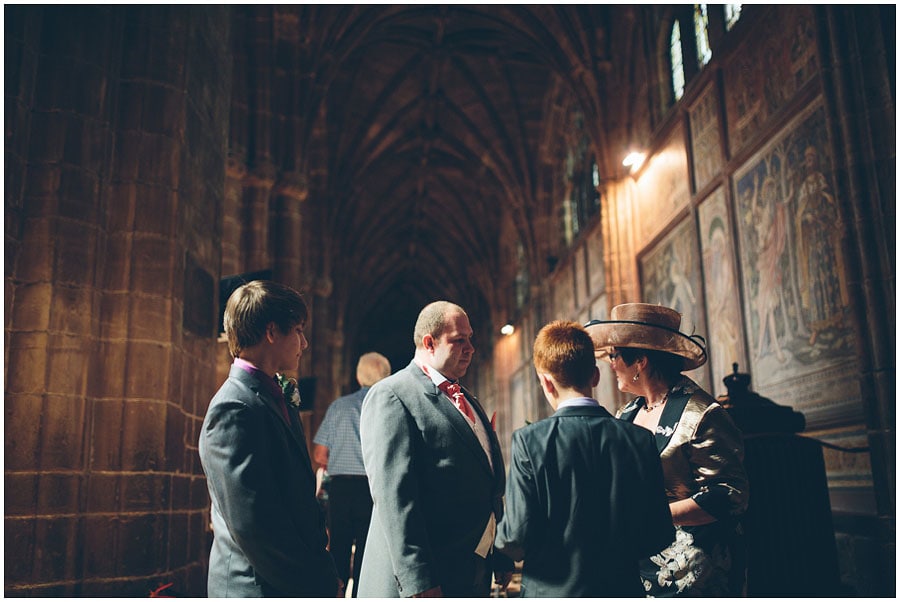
left=584, top=303, right=706, bottom=370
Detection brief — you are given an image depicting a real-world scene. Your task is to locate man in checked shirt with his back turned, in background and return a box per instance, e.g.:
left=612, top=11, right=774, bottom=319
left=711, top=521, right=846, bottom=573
left=313, top=352, right=391, bottom=598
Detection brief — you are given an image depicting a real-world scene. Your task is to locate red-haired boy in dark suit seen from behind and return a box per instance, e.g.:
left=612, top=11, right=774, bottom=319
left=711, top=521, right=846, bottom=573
left=496, top=321, right=675, bottom=598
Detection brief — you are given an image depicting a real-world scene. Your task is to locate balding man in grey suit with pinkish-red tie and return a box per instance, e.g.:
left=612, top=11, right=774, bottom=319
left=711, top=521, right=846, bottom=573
left=359, top=301, right=512, bottom=598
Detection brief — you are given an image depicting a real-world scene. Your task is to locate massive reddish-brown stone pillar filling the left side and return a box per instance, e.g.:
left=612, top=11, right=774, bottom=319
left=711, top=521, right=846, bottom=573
left=4, top=6, right=230, bottom=597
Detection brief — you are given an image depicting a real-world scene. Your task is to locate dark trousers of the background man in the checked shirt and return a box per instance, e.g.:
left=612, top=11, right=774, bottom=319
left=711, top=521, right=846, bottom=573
left=328, top=475, right=372, bottom=598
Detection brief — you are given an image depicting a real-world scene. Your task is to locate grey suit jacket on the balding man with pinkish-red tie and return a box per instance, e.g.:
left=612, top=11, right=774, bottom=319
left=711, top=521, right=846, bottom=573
left=359, top=362, right=512, bottom=598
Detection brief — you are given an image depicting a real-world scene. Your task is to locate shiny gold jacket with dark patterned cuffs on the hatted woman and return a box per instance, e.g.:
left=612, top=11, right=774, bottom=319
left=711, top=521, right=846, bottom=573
left=617, top=376, right=749, bottom=520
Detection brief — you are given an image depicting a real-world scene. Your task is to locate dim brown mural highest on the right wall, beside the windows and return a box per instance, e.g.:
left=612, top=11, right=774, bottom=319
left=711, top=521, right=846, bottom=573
left=724, top=4, right=819, bottom=154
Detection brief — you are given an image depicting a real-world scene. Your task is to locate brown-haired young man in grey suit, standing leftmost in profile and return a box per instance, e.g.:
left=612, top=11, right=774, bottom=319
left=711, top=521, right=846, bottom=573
left=200, top=281, right=340, bottom=598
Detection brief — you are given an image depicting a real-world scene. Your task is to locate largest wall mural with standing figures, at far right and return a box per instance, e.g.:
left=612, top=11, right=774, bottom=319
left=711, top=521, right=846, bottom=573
left=735, top=101, right=860, bottom=422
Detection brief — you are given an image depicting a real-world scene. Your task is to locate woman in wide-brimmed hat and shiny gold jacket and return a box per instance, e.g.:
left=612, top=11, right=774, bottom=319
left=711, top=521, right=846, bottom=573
left=585, top=303, right=748, bottom=596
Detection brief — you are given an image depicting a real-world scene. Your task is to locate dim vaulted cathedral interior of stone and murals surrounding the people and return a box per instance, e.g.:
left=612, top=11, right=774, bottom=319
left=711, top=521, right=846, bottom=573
left=4, top=4, right=896, bottom=597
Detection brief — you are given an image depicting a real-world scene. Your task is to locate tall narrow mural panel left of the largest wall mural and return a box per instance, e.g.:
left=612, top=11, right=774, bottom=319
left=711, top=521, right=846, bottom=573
left=698, top=188, right=749, bottom=396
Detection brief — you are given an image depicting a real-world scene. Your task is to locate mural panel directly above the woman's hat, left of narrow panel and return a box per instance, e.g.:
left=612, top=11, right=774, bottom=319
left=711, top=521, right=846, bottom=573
left=641, top=219, right=710, bottom=391
